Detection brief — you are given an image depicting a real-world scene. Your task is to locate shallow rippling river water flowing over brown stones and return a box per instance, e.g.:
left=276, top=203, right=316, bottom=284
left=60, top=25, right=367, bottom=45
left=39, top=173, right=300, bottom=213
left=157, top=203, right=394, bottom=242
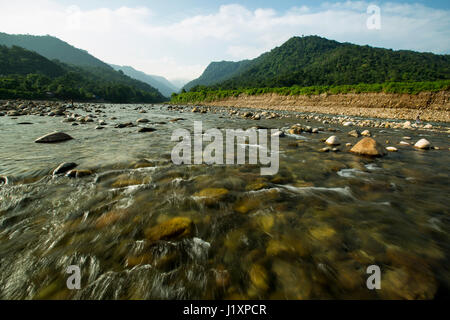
left=0, top=105, right=450, bottom=299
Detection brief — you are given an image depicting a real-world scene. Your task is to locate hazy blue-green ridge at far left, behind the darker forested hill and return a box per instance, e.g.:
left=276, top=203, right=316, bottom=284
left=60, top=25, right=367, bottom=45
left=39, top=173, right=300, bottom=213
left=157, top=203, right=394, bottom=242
left=0, top=32, right=111, bottom=69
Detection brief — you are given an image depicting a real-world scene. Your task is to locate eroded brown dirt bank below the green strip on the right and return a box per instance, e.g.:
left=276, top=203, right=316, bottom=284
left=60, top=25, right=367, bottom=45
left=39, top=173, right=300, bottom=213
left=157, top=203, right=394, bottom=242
left=191, top=91, right=450, bottom=122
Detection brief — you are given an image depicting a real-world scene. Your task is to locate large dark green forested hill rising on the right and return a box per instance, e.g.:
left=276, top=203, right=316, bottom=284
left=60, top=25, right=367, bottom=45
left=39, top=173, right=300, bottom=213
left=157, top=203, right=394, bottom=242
left=188, top=36, right=450, bottom=91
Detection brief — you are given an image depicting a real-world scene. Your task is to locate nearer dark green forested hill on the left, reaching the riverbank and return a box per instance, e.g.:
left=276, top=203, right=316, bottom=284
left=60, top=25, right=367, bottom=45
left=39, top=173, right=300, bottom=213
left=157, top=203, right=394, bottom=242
left=0, top=46, right=165, bottom=103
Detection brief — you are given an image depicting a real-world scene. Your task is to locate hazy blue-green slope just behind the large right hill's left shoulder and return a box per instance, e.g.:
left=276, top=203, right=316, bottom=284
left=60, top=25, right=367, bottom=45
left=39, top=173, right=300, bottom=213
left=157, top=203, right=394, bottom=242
left=183, top=60, right=252, bottom=90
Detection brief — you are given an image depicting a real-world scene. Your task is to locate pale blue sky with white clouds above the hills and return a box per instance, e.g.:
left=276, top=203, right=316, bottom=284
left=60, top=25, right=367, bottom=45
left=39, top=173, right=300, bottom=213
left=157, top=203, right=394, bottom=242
left=0, top=0, right=450, bottom=81
